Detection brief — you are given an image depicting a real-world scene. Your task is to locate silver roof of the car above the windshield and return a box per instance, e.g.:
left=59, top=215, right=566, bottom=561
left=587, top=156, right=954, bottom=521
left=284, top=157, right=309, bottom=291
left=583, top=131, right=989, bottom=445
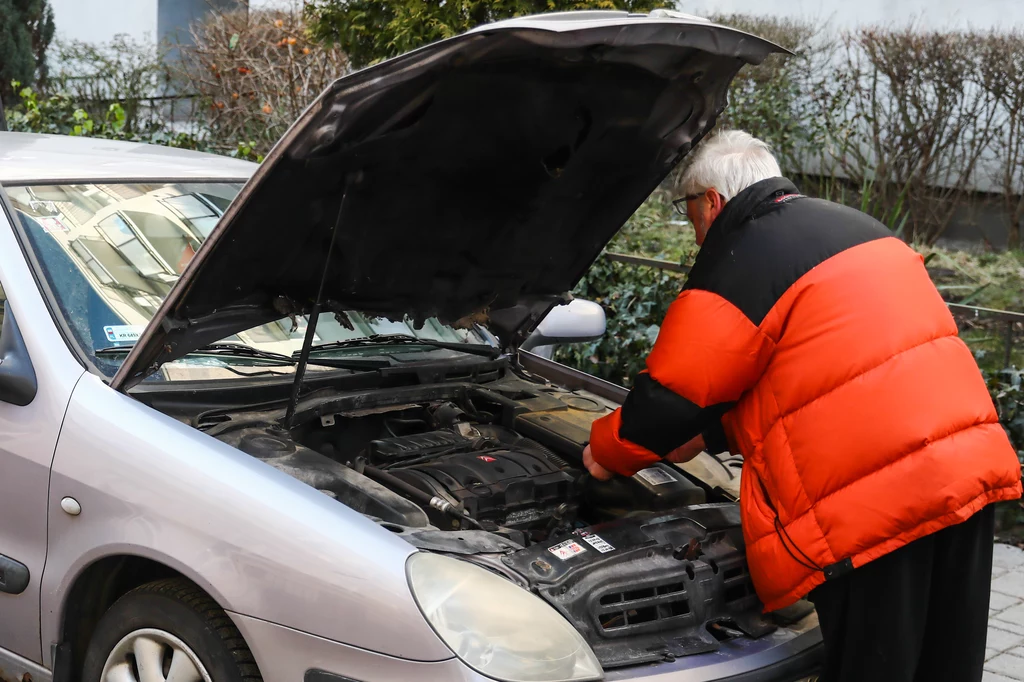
left=0, top=132, right=258, bottom=184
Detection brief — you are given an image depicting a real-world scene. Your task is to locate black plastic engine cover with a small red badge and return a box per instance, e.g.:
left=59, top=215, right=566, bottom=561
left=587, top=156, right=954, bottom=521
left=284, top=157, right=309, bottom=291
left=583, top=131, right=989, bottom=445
left=389, top=450, right=574, bottom=530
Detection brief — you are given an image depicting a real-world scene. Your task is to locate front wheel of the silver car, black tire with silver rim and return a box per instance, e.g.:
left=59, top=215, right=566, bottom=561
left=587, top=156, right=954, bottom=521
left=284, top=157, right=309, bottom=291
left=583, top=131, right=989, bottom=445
left=82, top=579, right=263, bottom=682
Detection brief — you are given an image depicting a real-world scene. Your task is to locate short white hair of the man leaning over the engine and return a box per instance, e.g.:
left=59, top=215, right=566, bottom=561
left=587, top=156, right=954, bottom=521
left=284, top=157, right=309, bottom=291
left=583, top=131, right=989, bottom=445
left=680, top=130, right=782, bottom=201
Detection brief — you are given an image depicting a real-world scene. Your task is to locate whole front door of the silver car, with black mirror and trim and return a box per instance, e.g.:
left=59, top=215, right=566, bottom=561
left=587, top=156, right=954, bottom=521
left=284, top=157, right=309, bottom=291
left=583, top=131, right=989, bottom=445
left=0, top=201, right=84, bottom=659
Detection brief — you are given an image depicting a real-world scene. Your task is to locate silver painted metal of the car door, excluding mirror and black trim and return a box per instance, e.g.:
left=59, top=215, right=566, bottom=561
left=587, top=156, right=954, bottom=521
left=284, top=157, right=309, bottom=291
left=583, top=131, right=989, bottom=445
left=0, top=196, right=85, bottom=663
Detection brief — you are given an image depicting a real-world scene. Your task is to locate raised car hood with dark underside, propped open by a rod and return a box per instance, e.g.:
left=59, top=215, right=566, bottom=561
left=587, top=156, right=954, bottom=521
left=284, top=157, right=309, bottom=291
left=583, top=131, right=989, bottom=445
left=112, top=11, right=783, bottom=389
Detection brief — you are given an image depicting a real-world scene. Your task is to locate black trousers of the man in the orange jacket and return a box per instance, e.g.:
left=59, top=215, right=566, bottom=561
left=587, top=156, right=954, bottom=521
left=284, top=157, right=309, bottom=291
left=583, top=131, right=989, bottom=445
left=808, top=505, right=995, bottom=682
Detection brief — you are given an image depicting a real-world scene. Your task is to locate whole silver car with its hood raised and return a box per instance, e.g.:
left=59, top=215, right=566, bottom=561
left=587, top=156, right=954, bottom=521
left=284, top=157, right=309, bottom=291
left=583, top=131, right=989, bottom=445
left=0, top=12, right=821, bottom=682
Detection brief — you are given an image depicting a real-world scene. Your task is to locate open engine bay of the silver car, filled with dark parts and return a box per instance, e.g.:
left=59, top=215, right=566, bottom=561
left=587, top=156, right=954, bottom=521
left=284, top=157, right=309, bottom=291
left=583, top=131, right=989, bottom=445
left=194, top=375, right=775, bottom=668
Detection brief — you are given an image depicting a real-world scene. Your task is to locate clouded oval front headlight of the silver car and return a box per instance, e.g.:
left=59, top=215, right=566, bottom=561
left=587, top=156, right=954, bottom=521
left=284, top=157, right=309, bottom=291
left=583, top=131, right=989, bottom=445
left=407, top=552, right=602, bottom=682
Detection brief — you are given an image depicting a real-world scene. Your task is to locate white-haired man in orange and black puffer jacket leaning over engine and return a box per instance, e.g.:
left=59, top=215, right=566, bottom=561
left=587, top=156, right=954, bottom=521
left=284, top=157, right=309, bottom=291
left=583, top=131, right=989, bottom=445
left=584, top=131, right=1021, bottom=682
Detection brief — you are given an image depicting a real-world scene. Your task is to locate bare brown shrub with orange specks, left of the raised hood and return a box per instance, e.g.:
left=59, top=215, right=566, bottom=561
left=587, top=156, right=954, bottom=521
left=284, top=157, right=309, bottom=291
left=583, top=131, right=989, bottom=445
left=179, top=6, right=348, bottom=154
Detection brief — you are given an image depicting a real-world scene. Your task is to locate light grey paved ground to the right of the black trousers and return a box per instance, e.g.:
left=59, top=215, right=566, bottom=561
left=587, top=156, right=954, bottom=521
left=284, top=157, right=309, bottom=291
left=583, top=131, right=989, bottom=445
left=983, top=545, right=1024, bottom=682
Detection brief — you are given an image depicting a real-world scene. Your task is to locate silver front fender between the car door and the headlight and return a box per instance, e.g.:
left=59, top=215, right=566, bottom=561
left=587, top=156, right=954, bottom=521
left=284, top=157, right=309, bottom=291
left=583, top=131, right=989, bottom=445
left=42, top=368, right=452, bottom=660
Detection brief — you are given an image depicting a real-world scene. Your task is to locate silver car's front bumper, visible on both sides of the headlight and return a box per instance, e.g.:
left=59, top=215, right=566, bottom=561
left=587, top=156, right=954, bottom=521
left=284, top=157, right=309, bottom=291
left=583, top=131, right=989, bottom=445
left=228, top=613, right=823, bottom=682
